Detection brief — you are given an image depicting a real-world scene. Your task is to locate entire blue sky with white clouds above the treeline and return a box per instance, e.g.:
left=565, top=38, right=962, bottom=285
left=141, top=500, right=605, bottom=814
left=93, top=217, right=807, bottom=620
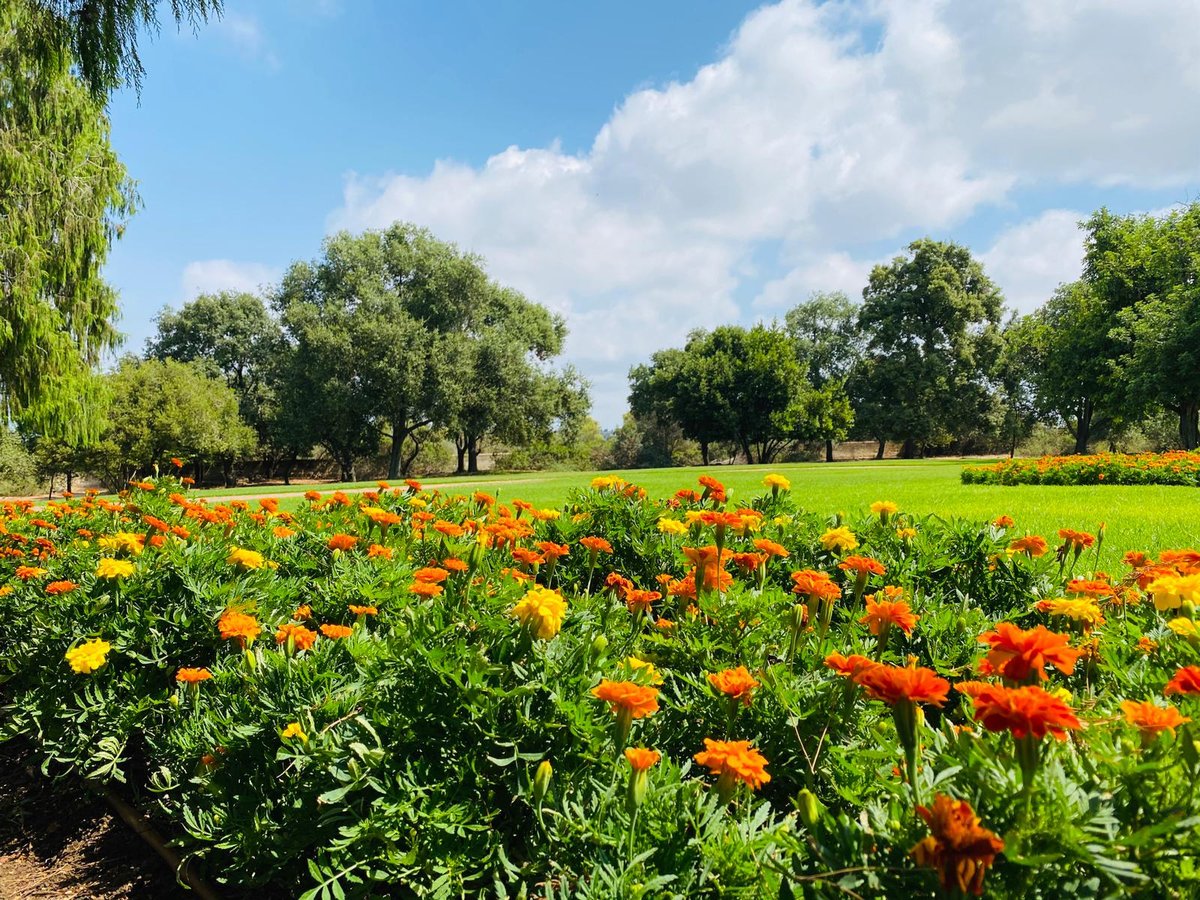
left=100, top=0, right=1200, bottom=426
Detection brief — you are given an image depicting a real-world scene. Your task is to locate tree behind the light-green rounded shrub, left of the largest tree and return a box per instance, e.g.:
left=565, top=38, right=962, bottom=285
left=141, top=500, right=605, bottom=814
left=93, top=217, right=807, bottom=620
left=145, top=292, right=287, bottom=465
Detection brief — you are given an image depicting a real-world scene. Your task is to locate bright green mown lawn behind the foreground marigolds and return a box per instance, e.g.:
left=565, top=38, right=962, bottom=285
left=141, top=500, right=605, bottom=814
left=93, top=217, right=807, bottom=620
left=182, top=460, right=1200, bottom=570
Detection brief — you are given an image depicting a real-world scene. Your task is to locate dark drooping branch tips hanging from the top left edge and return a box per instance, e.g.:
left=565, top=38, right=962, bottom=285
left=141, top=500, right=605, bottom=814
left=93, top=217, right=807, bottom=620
left=24, top=0, right=222, bottom=102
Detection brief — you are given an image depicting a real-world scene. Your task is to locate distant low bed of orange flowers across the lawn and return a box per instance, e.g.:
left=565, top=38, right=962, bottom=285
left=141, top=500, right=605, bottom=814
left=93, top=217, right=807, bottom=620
left=962, top=450, right=1200, bottom=487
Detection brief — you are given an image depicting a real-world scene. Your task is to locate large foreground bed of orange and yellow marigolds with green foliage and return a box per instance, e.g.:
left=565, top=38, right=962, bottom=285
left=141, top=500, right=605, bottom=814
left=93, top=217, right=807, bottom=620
left=0, top=476, right=1200, bottom=898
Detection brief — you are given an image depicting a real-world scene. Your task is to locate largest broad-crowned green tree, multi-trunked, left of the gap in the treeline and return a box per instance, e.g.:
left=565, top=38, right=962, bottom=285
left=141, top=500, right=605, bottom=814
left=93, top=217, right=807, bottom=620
left=275, top=223, right=587, bottom=480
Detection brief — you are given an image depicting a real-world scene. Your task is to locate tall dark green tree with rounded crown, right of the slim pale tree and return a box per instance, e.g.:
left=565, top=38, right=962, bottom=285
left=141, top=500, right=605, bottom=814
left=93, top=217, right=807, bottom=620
left=856, top=239, right=1002, bottom=457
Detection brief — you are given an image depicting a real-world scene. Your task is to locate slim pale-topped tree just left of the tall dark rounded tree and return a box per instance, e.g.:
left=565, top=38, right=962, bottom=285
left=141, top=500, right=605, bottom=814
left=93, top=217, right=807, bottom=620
left=785, top=292, right=862, bottom=462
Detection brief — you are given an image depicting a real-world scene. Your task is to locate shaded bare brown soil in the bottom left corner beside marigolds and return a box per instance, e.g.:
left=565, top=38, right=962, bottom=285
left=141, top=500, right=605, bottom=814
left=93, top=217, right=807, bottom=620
left=0, top=744, right=190, bottom=900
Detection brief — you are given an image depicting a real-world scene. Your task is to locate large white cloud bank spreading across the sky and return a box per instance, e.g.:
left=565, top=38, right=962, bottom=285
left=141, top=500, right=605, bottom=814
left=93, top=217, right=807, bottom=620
left=330, top=0, right=1200, bottom=424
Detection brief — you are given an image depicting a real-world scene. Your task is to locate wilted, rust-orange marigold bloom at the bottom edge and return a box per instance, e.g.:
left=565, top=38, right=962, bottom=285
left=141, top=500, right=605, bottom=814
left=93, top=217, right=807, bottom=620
left=908, top=793, right=1004, bottom=896
